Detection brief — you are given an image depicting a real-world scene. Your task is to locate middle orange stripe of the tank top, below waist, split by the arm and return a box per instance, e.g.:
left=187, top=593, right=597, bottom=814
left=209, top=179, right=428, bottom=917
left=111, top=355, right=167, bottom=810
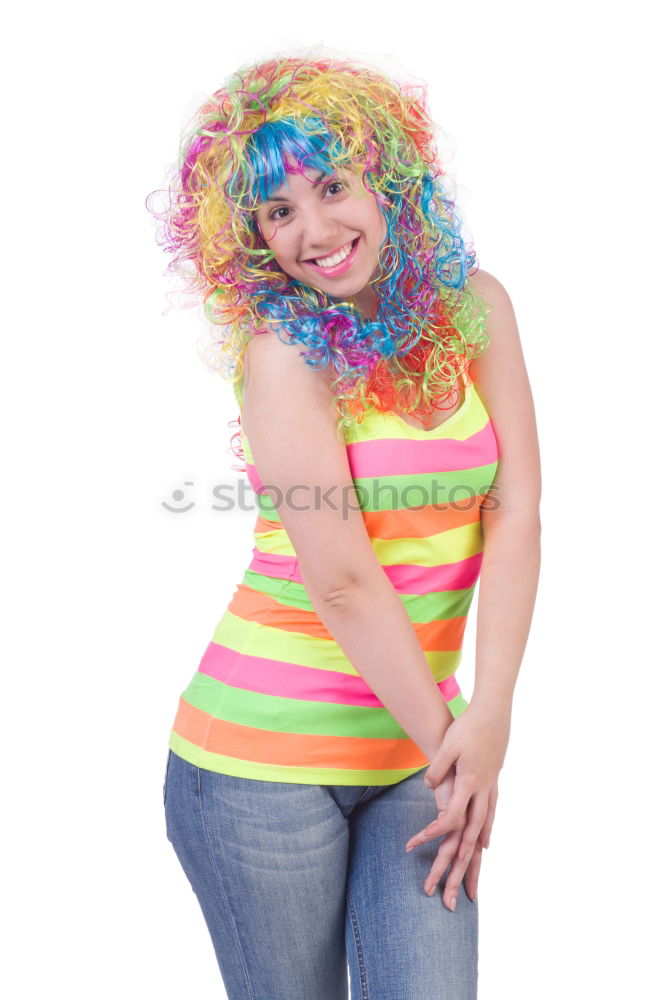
left=228, top=584, right=467, bottom=652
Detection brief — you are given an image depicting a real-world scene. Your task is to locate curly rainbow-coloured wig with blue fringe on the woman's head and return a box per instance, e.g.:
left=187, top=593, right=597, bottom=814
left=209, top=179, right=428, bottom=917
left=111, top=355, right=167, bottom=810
left=150, top=57, right=488, bottom=460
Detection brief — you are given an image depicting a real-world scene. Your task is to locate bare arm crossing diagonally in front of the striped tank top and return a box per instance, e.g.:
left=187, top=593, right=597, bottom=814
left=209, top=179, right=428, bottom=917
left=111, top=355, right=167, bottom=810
left=242, top=332, right=453, bottom=761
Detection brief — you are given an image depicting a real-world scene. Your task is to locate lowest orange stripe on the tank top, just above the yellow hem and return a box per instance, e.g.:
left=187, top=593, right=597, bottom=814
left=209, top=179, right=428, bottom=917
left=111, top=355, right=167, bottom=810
left=173, top=697, right=428, bottom=771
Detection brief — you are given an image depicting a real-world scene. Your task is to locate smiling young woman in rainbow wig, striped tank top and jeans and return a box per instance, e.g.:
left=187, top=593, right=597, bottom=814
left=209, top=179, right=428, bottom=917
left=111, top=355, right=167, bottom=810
left=152, top=58, right=540, bottom=1000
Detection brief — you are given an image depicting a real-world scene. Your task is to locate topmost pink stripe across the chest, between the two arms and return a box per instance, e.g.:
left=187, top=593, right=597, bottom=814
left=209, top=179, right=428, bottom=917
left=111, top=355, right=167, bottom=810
left=347, top=420, right=499, bottom=479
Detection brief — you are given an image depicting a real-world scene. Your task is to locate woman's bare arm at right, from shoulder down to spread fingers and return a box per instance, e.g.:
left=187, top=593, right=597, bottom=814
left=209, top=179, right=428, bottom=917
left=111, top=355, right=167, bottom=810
left=408, top=271, right=541, bottom=907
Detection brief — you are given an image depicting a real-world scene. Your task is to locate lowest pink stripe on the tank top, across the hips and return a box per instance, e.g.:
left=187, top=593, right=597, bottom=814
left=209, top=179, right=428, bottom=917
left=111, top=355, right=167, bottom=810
left=198, top=642, right=460, bottom=708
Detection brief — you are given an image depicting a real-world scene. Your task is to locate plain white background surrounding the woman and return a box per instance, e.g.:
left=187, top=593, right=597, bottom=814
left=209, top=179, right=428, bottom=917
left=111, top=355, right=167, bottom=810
left=1, top=0, right=660, bottom=1000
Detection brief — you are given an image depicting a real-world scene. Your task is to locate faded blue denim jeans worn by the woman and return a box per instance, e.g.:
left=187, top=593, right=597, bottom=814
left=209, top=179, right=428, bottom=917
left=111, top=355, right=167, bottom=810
left=163, top=749, right=478, bottom=1000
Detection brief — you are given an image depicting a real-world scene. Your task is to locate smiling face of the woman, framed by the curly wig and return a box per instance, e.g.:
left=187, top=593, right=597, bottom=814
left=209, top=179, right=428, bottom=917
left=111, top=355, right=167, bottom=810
left=256, top=160, right=387, bottom=312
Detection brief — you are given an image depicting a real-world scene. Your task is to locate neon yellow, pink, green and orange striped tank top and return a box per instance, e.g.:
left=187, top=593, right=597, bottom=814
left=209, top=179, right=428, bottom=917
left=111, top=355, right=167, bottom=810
left=168, top=366, right=498, bottom=785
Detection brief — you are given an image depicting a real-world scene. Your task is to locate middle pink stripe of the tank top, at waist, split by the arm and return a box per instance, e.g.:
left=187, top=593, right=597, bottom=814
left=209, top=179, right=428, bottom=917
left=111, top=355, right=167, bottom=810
left=248, top=548, right=483, bottom=594
